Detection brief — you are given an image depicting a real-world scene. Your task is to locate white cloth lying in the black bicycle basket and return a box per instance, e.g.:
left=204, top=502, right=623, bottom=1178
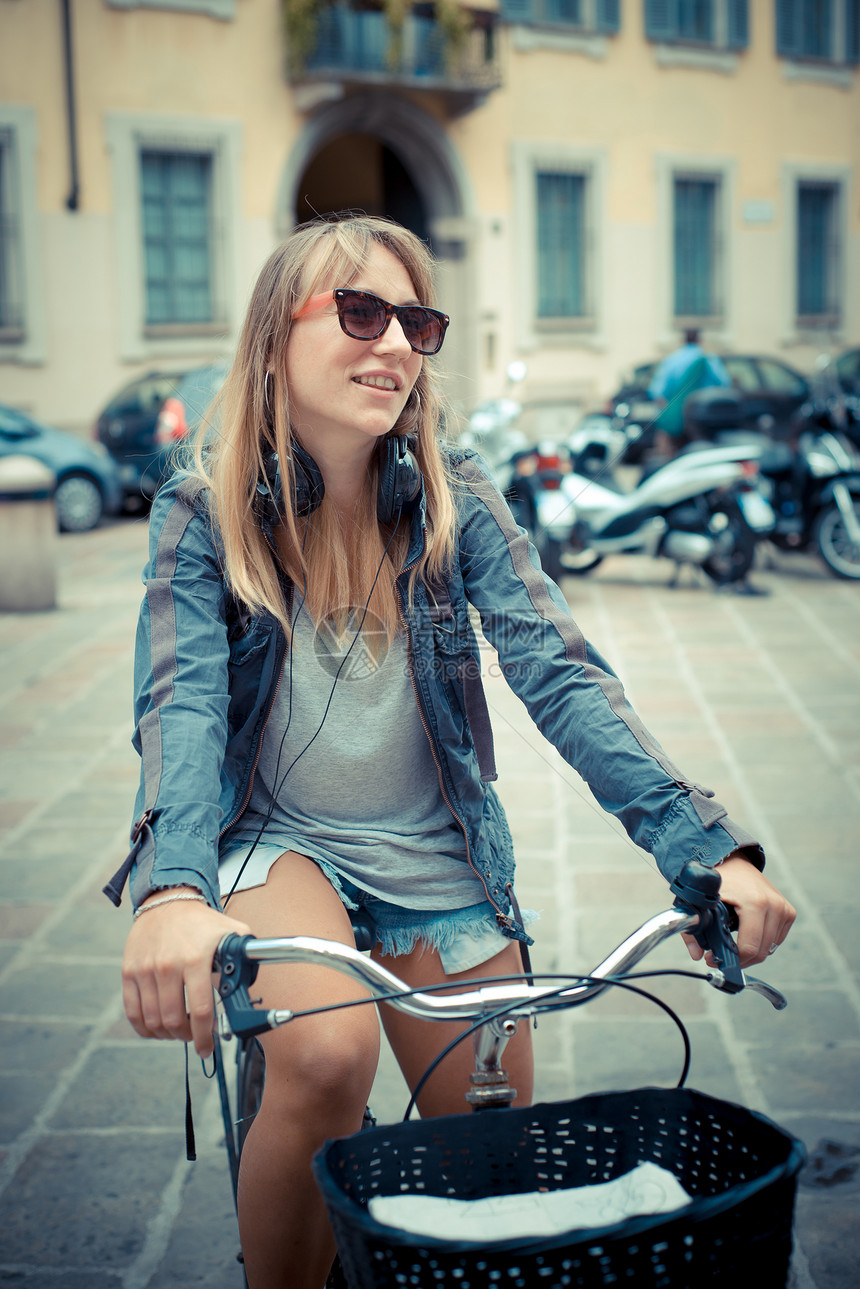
left=367, top=1163, right=690, bottom=1244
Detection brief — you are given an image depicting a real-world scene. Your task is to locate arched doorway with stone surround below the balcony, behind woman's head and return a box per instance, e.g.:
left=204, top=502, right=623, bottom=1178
left=277, top=92, right=478, bottom=410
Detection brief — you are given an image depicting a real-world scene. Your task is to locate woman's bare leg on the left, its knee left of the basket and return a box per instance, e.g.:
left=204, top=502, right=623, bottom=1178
left=230, top=851, right=379, bottom=1289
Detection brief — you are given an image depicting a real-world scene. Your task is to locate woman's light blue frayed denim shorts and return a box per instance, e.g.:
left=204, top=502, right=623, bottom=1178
left=218, top=842, right=528, bottom=976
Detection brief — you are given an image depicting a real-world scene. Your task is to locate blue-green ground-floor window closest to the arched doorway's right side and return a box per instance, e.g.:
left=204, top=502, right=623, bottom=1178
left=535, top=170, right=588, bottom=321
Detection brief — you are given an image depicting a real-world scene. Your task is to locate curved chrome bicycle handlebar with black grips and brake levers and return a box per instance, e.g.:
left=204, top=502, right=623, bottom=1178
left=214, top=861, right=787, bottom=1038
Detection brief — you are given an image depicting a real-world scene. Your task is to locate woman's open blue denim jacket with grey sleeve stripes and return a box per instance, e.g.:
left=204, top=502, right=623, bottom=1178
left=104, top=450, right=763, bottom=942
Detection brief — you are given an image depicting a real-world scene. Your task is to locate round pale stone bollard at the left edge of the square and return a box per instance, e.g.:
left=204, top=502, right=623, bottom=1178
left=0, top=455, right=57, bottom=612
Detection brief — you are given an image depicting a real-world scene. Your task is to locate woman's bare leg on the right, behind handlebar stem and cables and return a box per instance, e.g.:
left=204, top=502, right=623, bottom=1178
left=373, top=941, right=534, bottom=1119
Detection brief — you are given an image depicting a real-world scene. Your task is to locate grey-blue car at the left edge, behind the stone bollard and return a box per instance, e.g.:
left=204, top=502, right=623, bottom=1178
left=0, top=405, right=122, bottom=532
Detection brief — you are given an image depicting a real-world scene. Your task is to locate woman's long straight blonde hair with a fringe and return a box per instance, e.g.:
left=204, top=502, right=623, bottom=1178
left=192, top=215, right=455, bottom=637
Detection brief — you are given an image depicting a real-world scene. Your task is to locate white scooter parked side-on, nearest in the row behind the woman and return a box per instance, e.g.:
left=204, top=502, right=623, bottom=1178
left=538, top=438, right=774, bottom=585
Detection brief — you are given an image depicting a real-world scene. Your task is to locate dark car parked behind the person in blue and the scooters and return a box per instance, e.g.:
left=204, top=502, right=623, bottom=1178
left=606, top=353, right=811, bottom=438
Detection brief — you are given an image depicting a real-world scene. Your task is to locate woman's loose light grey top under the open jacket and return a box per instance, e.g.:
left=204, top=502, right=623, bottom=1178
left=230, top=600, right=486, bottom=909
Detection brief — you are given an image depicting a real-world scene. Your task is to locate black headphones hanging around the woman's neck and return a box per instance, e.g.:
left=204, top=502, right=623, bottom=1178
left=254, top=434, right=422, bottom=526
